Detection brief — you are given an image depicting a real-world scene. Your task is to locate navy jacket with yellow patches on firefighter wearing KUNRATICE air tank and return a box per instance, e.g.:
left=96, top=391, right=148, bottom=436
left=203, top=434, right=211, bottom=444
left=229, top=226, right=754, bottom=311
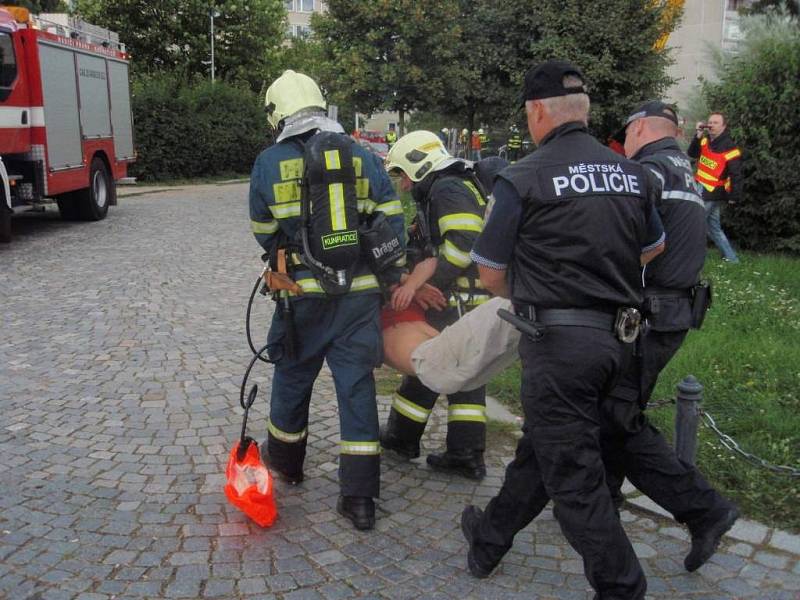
left=250, top=132, right=404, bottom=297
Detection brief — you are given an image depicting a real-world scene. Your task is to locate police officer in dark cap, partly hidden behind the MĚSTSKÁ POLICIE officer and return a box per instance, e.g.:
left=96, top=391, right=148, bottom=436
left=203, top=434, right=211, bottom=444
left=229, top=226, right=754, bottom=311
left=602, top=100, right=738, bottom=571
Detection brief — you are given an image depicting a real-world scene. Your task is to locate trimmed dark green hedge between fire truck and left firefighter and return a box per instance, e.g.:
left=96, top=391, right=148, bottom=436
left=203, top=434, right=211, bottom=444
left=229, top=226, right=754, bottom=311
left=130, top=76, right=266, bottom=181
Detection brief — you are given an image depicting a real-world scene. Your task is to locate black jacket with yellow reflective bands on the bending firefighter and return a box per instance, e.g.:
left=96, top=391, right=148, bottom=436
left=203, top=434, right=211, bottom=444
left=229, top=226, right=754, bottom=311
left=412, top=161, right=489, bottom=309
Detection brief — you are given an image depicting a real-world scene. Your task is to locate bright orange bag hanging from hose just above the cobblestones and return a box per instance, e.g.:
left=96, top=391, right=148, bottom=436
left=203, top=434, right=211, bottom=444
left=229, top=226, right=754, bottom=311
left=225, top=438, right=278, bottom=527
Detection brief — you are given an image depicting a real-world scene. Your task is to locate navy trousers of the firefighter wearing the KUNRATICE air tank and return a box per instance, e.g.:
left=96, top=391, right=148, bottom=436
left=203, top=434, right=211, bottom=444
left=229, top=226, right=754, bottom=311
left=267, top=294, right=382, bottom=497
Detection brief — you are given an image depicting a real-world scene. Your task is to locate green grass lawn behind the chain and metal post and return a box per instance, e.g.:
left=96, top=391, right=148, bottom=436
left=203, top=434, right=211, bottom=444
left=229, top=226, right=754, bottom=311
left=488, top=250, right=800, bottom=531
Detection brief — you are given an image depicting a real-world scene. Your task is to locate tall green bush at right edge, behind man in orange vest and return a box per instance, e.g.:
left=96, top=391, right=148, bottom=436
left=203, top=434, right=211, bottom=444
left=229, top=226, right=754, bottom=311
left=702, top=15, right=800, bottom=253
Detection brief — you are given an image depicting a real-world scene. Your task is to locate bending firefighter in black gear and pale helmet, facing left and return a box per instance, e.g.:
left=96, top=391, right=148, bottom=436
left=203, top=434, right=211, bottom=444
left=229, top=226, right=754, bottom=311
left=381, top=131, right=489, bottom=479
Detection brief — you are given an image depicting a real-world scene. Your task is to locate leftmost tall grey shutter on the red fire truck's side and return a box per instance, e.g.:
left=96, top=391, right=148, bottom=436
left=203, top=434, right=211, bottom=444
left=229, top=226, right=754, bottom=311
left=39, top=42, right=83, bottom=170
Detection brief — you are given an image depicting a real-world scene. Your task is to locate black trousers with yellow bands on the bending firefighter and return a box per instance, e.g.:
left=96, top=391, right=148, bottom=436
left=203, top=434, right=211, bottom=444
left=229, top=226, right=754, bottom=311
left=386, top=308, right=486, bottom=453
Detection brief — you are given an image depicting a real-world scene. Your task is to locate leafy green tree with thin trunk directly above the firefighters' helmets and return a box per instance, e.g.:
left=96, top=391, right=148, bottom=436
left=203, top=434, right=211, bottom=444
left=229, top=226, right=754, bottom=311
left=312, top=0, right=459, bottom=134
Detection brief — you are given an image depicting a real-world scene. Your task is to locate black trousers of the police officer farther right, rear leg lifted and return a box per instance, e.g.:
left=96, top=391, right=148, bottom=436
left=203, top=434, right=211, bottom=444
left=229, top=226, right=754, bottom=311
left=601, top=331, right=731, bottom=531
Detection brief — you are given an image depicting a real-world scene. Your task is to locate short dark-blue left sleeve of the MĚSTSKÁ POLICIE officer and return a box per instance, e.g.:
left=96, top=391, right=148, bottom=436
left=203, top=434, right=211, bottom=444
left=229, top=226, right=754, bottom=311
left=470, top=178, right=520, bottom=270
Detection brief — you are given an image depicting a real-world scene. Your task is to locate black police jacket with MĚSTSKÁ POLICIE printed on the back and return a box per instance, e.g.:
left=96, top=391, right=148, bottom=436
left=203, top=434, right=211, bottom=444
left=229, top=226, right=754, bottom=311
left=500, top=122, right=663, bottom=312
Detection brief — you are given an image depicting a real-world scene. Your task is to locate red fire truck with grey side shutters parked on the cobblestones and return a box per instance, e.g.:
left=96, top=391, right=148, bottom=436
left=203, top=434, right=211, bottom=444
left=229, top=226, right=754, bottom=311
left=0, top=7, right=135, bottom=241
